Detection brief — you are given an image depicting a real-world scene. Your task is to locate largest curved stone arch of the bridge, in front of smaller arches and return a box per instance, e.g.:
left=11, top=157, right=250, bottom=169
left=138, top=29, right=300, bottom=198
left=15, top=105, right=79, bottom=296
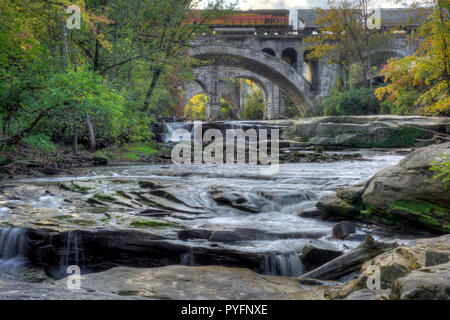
left=190, top=44, right=312, bottom=118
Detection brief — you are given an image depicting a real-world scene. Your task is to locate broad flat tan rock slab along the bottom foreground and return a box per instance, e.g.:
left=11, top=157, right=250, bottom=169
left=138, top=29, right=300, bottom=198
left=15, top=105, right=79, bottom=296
left=75, top=266, right=329, bottom=300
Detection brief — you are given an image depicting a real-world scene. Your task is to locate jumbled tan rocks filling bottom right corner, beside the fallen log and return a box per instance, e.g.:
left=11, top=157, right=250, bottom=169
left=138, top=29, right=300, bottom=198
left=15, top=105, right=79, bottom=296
left=326, top=235, right=450, bottom=300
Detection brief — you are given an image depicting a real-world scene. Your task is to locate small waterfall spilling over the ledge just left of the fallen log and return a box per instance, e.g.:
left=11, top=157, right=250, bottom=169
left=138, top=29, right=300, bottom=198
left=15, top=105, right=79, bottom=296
left=263, top=253, right=304, bottom=277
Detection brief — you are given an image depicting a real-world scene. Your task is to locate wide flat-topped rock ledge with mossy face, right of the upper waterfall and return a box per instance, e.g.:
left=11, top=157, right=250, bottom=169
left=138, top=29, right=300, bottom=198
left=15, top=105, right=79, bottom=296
left=277, top=115, right=450, bottom=148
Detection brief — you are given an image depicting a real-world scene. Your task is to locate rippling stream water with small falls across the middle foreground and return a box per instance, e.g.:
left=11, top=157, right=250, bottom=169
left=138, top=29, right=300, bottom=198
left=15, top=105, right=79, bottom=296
left=0, top=131, right=428, bottom=276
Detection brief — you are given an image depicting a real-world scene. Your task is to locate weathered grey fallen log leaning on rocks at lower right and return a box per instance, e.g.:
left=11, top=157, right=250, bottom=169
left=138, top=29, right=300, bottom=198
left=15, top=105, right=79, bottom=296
left=300, top=235, right=398, bottom=280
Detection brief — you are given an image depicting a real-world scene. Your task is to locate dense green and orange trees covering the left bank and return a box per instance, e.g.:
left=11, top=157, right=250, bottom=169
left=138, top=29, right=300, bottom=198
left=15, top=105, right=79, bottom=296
left=0, top=0, right=236, bottom=156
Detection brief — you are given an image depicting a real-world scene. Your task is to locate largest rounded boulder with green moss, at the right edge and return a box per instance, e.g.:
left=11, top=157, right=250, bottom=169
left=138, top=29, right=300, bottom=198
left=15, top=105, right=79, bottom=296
left=362, top=143, right=450, bottom=232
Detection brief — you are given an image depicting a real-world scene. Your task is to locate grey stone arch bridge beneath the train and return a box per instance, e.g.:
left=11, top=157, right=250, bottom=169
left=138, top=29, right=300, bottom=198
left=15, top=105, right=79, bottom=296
left=180, top=34, right=415, bottom=119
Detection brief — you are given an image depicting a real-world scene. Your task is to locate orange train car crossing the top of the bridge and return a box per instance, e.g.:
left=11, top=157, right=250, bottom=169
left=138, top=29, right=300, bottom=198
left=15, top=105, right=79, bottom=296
left=191, top=10, right=292, bottom=34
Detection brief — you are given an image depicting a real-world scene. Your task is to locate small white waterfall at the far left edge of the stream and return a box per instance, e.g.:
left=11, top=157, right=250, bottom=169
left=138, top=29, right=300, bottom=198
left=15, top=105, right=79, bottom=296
left=0, top=228, right=28, bottom=279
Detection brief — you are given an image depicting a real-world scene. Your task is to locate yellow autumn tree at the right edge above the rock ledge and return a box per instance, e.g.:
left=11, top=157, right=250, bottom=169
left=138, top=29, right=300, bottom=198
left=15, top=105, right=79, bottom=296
left=376, top=0, right=450, bottom=116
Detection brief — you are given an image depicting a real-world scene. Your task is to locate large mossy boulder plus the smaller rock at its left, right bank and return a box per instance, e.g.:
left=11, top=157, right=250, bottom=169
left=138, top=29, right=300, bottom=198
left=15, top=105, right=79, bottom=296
left=317, top=143, right=450, bottom=233
